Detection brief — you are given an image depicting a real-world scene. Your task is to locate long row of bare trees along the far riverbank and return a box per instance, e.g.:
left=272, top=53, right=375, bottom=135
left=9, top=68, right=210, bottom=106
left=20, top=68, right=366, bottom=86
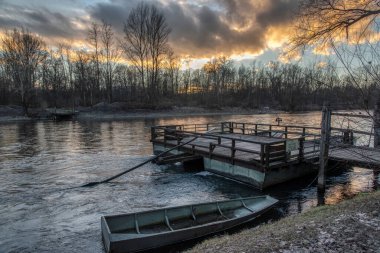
left=0, top=3, right=376, bottom=113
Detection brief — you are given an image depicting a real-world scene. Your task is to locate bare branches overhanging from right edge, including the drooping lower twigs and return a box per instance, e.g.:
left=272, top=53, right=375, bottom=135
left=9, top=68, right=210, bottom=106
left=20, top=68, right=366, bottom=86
left=287, top=0, right=380, bottom=108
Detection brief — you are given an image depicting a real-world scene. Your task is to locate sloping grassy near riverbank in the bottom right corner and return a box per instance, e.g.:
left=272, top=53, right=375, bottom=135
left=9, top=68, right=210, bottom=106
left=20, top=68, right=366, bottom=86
left=187, top=191, right=380, bottom=253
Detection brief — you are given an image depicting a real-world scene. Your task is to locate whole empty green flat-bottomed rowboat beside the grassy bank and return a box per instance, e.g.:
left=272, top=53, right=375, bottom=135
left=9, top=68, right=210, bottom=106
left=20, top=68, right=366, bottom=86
left=101, top=196, right=278, bottom=253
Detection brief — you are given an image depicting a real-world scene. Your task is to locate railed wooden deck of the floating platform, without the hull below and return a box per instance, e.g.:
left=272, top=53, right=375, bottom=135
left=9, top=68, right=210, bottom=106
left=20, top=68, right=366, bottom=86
left=151, top=122, right=319, bottom=170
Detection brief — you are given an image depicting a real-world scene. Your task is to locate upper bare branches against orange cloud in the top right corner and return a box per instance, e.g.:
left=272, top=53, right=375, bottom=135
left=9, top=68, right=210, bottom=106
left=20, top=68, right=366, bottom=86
left=291, top=0, right=380, bottom=52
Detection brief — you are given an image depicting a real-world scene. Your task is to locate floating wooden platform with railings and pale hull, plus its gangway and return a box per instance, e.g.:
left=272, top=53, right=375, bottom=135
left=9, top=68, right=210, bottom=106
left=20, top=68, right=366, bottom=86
left=151, top=122, right=380, bottom=188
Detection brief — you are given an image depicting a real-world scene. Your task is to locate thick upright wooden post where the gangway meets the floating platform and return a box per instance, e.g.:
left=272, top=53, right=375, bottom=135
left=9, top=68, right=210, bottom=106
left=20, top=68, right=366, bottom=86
left=318, top=103, right=331, bottom=191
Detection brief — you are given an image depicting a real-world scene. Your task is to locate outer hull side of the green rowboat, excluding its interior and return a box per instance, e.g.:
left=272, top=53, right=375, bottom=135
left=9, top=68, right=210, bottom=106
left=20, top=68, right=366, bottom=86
left=101, top=200, right=277, bottom=253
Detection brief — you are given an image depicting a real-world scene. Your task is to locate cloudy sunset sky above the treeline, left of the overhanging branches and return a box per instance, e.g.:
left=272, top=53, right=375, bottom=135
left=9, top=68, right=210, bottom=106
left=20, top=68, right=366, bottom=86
left=0, top=0, right=314, bottom=68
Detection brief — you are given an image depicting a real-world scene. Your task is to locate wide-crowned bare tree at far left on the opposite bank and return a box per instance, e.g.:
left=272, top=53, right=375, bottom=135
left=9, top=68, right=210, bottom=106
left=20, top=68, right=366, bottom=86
left=1, top=29, right=47, bottom=114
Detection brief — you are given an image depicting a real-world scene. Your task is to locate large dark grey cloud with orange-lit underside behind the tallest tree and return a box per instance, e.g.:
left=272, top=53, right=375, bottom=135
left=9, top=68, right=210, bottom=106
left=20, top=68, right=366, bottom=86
left=89, top=0, right=297, bottom=57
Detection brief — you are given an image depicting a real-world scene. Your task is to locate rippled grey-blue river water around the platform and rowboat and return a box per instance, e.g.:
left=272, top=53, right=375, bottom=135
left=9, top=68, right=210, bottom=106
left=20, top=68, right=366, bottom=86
left=0, top=112, right=378, bottom=252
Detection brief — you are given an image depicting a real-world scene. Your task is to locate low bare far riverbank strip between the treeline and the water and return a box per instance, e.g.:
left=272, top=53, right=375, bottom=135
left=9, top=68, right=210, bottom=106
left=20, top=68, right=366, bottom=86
left=0, top=105, right=282, bottom=122
